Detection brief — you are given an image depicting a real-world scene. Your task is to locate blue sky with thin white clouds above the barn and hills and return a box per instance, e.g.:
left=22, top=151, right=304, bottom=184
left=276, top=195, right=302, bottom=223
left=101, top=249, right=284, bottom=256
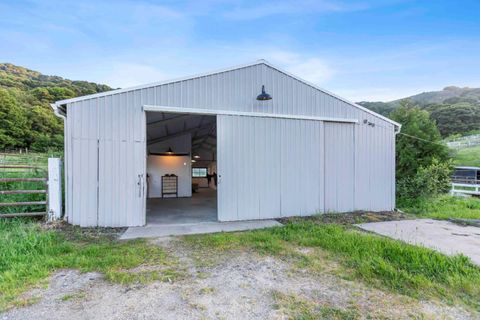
left=0, top=0, right=480, bottom=101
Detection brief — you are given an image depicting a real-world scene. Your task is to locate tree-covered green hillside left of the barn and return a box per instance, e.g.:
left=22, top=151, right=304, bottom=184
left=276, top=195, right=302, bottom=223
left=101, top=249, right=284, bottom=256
left=0, top=63, right=111, bottom=151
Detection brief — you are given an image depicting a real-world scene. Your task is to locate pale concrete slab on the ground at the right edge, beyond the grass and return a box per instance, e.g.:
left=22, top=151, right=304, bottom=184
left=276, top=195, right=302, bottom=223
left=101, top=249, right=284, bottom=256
left=357, top=219, right=480, bottom=265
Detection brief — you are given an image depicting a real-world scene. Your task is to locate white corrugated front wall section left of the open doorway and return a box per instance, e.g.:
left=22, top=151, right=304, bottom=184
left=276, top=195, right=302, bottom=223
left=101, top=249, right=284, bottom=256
left=66, top=92, right=146, bottom=227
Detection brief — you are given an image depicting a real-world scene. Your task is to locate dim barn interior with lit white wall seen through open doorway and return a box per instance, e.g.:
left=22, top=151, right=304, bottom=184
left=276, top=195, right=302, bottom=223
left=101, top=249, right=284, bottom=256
left=146, top=112, right=217, bottom=225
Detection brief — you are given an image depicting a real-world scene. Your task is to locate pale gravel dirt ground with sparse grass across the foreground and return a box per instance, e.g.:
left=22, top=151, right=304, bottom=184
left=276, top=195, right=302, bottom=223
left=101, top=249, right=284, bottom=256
left=0, top=240, right=476, bottom=319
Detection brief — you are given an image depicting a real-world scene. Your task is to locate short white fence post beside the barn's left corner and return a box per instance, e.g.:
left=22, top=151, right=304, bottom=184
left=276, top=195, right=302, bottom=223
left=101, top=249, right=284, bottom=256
left=48, top=158, right=62, bottom=221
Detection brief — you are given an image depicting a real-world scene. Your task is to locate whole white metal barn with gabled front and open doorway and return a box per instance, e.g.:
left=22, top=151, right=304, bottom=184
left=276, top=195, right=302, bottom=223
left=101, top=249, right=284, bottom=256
left=52, top=60, right=400, bottom=227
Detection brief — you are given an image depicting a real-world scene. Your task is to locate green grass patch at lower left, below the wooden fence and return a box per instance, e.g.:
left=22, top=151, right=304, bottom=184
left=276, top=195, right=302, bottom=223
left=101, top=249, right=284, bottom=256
left=0, top=219, right=182, bottom=311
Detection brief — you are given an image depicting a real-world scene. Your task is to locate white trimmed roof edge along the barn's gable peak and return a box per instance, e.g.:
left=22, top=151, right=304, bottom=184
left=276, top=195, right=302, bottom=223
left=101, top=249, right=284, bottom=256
left=51, top=60, right=401, bottom=128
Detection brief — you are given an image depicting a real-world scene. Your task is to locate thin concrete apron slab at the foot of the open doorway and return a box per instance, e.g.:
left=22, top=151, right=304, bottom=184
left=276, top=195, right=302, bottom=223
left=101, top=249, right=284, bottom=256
left=120, top=220, right=282, bottom=240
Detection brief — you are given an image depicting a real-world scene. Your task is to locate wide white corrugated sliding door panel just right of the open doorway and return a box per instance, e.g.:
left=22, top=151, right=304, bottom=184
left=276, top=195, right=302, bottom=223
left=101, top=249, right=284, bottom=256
left=217, top=115, right=324, bottom=221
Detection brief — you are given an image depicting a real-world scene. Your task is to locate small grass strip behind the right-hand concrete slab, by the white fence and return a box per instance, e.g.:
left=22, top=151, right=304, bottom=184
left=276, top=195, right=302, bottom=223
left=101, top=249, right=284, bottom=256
left=399, top=195, right=480, bottom=219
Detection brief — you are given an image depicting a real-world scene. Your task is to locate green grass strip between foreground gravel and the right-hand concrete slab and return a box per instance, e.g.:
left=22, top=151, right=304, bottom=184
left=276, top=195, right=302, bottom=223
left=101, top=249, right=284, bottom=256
left=185, top=221, right=480, bottom=310
